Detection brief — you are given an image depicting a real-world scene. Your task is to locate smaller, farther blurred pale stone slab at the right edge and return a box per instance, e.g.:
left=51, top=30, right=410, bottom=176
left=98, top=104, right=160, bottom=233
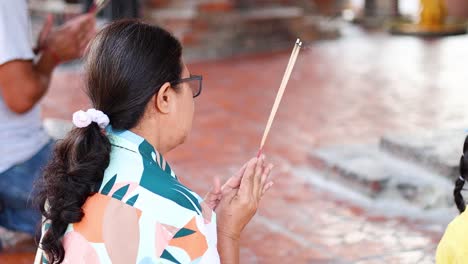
left=380, top=129, right=466, bottom=179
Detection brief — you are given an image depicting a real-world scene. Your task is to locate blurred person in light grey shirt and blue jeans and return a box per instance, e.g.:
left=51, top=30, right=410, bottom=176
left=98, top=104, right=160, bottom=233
left=0, top=0, right=95, bottom=250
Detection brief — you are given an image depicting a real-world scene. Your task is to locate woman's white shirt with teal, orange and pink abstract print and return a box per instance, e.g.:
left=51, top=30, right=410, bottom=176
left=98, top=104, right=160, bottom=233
left=44, top=128, right=220, bottom=264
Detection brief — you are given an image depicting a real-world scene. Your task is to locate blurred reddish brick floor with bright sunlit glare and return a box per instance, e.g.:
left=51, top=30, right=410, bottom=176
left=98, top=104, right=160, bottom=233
left=0, top=26, right=468, bottom=263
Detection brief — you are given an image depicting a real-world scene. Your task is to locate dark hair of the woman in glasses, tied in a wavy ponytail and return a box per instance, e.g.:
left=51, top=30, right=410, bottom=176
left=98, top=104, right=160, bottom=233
left=37, top=20, right=183, bottom=264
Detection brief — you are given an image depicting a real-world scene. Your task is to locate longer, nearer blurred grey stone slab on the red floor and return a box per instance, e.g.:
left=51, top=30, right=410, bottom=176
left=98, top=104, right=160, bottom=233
left=309, top=145, right=453, bottom=209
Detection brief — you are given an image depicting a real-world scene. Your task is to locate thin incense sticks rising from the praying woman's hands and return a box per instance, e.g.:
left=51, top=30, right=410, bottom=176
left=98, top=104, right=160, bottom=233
left=257, top=39, right=302, bottom=157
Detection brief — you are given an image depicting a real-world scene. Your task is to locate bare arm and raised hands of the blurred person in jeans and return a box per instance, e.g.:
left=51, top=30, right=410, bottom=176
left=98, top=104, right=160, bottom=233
left=0, top=7, right=95, bottom=114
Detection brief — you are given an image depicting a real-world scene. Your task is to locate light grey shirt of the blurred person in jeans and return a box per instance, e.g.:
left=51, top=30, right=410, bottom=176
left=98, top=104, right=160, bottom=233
left=0, top=0, right=50, bottom=173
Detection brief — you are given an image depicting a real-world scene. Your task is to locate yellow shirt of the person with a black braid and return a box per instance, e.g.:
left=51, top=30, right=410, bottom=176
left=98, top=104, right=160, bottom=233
left=436, top=211, right=468, bottom=264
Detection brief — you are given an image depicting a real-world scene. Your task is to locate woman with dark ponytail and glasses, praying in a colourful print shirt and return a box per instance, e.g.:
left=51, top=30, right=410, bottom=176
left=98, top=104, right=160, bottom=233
left=39, top=20, right=272, bottom=264
